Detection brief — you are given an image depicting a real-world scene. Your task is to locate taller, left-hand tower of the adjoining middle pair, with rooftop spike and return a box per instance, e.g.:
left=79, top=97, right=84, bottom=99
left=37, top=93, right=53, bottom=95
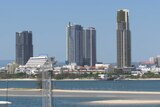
left=66, top=22, right=83, bottom=66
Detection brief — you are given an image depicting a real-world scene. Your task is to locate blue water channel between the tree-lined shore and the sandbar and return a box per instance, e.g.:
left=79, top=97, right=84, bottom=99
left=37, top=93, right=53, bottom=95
left=0, top=80, right=160, bottom=91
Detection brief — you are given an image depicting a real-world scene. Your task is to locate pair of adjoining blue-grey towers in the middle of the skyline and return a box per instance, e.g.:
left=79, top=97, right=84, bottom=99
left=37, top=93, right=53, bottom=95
left=66, top=23, right=96, bottom=66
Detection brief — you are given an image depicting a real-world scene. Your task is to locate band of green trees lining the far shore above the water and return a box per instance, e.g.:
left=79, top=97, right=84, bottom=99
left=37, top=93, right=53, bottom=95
left=0, top=71, right=160, bottom=80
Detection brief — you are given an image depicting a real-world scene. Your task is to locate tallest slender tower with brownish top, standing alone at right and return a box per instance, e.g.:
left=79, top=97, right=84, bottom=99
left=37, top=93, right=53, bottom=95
left=117, top=9, right=131, bottom=68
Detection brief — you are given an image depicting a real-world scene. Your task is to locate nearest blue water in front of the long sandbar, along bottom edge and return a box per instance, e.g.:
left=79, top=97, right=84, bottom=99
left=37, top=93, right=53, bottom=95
left=0, top=97, right=160, bottom=107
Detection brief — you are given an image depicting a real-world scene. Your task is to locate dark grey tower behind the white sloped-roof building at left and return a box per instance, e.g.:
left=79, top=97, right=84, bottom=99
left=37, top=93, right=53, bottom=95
left=16, top=31, right=33, bottom=65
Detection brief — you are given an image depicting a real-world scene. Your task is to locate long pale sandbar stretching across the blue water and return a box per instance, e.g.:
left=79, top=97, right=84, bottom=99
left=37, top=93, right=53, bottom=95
left=0, top=88, right=160, bottom=105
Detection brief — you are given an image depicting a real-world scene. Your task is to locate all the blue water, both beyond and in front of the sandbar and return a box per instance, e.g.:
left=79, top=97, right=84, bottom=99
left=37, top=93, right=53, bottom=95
left=0, top=80, right=160, bottom=107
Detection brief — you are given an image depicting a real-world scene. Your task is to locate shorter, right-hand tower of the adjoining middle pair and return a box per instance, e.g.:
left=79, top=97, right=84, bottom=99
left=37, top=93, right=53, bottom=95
left=83, top=27, right=96, bottom=66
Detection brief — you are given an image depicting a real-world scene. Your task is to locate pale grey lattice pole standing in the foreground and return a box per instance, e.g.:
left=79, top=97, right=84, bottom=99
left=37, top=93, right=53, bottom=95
left=41, top=57, right=56, bottom=107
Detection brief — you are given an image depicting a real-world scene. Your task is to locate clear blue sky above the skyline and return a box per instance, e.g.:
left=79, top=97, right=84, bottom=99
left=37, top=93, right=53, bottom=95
left=0, top=0, right=160, bottom=63
